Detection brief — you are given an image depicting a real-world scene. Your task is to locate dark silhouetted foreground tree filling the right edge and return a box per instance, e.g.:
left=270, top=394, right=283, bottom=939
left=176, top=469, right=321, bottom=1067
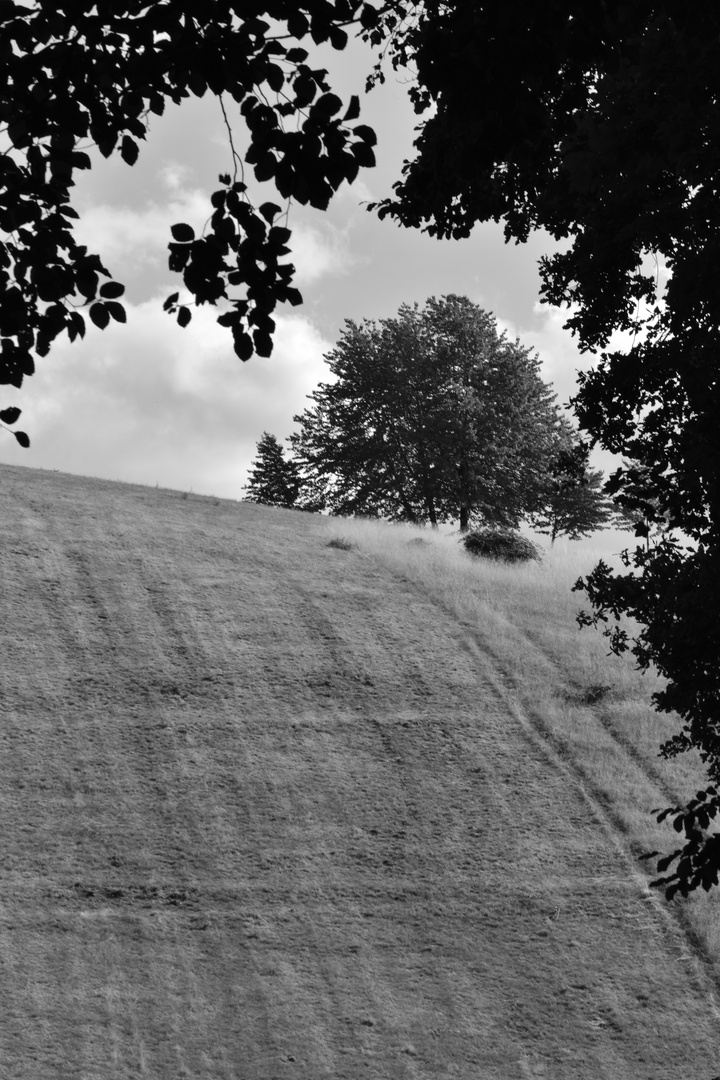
left=376, top=0, right=720, bottom=896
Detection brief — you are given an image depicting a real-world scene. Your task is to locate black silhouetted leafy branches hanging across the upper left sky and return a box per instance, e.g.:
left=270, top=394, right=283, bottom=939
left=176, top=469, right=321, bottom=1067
left=0, top=0, right=394, bottom=387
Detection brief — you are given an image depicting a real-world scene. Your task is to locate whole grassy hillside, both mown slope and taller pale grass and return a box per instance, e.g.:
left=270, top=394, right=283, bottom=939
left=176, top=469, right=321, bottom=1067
left=0, top=467, right=720, bottom=1080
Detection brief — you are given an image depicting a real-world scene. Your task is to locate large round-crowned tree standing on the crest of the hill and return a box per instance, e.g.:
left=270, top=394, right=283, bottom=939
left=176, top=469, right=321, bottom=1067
left=290, top=296, right=559, bottom=530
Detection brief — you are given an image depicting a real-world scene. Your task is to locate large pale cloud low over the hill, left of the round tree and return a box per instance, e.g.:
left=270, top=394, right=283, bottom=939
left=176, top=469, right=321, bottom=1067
left=0, top=299, right=330, bottom=498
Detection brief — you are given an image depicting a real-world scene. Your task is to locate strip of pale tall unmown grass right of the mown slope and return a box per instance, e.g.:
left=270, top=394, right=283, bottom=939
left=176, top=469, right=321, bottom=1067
left=323, top=518, right=720, bottom=975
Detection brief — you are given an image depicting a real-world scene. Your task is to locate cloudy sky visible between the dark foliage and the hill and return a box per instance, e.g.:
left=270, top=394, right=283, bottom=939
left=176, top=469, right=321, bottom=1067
left=0, top=31, right=600, bottom=499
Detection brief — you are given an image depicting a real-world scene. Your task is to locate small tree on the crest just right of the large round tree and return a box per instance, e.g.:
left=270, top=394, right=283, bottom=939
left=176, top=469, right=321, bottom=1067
left=531, top=421, right=616, bottom=543
